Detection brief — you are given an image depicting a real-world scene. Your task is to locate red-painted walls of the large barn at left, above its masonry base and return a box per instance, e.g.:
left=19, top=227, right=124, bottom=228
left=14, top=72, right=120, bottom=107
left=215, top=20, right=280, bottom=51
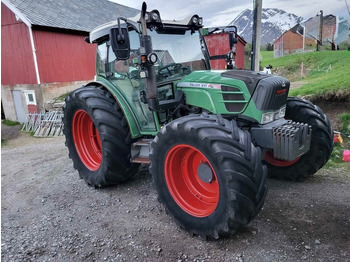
left=1, top=3, right=96, bottom=85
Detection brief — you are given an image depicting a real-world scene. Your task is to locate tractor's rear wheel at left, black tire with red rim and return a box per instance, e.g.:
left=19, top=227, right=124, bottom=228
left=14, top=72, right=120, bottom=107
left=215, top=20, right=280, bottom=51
left=63, top=86, right=139, bottom=187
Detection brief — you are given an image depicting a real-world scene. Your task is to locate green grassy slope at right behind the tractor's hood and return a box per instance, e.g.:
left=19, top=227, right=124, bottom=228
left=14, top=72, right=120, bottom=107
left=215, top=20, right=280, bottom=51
left=261, top=51, right=350, bottom=96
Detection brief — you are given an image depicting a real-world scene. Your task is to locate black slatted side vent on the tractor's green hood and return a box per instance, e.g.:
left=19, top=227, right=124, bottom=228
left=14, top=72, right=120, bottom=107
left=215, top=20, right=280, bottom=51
left=221, top=86, right=247, bottom=113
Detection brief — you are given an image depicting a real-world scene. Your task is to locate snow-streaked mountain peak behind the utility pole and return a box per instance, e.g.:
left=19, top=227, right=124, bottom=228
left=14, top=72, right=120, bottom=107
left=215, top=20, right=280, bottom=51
left=230, top=8, right=303, bottom=45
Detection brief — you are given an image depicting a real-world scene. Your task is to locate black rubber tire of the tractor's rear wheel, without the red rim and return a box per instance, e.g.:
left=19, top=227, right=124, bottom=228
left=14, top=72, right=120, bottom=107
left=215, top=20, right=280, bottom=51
left=63, top=86, right=139, bottom=187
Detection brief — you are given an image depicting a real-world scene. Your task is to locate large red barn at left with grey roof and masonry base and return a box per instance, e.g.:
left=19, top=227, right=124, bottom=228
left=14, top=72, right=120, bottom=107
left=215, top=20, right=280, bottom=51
left=1, top=0, right=139, bottom=122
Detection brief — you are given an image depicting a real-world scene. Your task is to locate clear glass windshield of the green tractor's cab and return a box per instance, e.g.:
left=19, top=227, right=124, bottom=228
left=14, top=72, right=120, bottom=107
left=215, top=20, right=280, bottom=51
left=130, top=31, right=206, bottom=83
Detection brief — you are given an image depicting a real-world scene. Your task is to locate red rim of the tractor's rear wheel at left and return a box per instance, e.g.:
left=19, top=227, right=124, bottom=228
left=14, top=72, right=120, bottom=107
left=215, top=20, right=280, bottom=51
left=72, top=110, right=102, bottom=171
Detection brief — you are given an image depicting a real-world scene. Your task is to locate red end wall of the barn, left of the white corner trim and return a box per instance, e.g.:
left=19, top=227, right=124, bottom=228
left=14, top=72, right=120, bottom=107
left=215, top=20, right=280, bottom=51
left=1, top=3, right=37, bottom=85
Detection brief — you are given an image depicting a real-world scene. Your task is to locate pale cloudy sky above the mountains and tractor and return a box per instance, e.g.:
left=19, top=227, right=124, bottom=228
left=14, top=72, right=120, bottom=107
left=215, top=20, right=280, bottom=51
left=110, top=0, right=350, bottom=27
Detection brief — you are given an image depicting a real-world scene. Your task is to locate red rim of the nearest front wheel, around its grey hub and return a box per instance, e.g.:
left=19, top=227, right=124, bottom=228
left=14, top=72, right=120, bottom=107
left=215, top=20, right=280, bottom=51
left=165, top=145, right=219, bottom=217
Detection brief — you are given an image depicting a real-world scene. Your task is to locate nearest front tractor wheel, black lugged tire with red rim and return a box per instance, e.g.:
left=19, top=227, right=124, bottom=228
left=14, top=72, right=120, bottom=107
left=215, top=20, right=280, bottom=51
left=150, top=115, right=267, bottom=238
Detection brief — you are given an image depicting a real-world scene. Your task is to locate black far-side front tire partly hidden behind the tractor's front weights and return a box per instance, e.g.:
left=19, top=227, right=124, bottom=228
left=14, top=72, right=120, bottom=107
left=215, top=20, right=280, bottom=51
left=265, top=97, right=333, bottom=181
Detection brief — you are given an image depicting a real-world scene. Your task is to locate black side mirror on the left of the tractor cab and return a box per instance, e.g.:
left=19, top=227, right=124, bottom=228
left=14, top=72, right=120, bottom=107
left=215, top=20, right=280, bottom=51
left=110, top=28, right=130, bottom=60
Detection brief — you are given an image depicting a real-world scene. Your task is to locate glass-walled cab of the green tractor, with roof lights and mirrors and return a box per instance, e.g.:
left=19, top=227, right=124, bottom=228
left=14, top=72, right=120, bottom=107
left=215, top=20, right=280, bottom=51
left=87, top=7, right=241, bottom=134
